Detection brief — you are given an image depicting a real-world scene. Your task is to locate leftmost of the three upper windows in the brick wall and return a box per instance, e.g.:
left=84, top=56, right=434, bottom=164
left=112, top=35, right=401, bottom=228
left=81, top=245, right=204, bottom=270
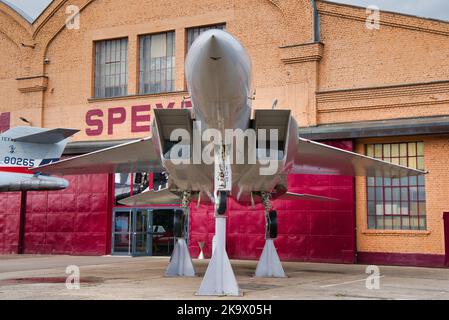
left=95, top=39, right=128, bottom=98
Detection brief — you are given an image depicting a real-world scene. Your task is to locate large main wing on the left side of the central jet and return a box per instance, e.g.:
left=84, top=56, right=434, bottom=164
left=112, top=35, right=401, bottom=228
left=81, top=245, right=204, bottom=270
left=31, top=138, right=164, bottom=175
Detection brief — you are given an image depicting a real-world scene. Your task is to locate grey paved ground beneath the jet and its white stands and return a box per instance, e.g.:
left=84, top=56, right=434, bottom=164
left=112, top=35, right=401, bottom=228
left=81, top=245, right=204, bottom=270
left=0, top=255, right=449, bottom=299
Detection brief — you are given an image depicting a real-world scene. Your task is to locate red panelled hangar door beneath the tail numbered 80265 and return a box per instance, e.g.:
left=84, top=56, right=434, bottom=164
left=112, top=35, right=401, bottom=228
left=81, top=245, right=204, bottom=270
left=0, top=174, right=111, bottom=255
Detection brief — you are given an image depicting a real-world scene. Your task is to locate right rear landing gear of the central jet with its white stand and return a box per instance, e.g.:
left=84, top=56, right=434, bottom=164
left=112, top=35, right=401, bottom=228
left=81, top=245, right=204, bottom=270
left=255, top=192, right=285, bottom=278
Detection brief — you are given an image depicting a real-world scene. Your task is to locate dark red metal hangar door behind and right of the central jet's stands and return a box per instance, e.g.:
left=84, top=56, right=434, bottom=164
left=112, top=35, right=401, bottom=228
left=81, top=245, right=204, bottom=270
left=189, top=141, right=355, bottom=263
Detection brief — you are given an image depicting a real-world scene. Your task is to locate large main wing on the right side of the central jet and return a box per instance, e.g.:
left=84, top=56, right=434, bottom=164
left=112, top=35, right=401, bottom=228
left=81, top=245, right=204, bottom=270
left=291, top=138, right=427, bottom=178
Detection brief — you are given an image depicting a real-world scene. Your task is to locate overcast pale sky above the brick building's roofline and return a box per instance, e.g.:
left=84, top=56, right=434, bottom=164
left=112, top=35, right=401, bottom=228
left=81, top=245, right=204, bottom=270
left=3, top=0, right=449, bottom=21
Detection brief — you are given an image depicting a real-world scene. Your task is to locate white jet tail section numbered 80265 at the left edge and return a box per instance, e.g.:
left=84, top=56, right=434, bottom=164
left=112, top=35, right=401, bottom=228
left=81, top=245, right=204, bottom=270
left=0, top=127, right=79, bottom=192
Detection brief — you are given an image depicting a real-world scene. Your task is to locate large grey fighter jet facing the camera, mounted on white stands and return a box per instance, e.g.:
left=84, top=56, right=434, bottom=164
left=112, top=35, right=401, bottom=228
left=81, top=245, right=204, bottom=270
left=34, top=30, right=426, bottom=295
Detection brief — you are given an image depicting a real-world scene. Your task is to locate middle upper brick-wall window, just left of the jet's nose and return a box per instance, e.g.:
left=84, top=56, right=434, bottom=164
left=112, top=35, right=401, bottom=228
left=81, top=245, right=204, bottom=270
left=139, top=31, right=175, bottom=94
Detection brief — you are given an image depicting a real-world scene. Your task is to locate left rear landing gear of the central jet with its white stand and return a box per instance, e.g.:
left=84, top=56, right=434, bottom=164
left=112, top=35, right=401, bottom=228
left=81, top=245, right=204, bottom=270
left=165, top=191, right=195, bottom=277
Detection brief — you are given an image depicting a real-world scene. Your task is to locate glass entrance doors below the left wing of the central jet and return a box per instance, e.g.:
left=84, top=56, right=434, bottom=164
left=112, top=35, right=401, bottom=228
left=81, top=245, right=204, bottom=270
left=112, top=208, right=153, bottom=256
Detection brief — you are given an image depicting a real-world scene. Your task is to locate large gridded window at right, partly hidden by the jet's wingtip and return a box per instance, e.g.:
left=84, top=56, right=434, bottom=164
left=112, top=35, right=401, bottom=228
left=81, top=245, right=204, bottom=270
left=366, top=142, right=427, bottom=230
